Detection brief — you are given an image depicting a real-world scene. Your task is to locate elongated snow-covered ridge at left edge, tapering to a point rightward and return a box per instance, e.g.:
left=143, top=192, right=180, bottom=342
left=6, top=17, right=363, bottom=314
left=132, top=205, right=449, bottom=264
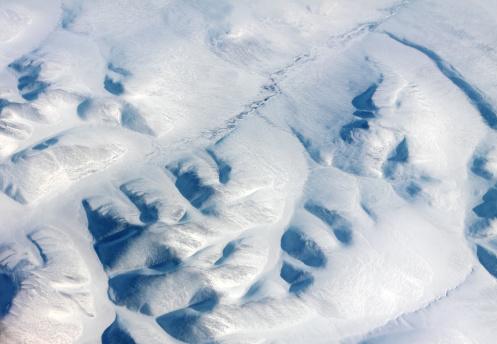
left=0, top=130, right=126, bottom=204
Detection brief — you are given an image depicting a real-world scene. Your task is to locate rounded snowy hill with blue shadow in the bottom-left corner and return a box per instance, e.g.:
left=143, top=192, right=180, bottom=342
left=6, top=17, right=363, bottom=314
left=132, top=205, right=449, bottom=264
left=0, top=227, right=95, bottom=344
